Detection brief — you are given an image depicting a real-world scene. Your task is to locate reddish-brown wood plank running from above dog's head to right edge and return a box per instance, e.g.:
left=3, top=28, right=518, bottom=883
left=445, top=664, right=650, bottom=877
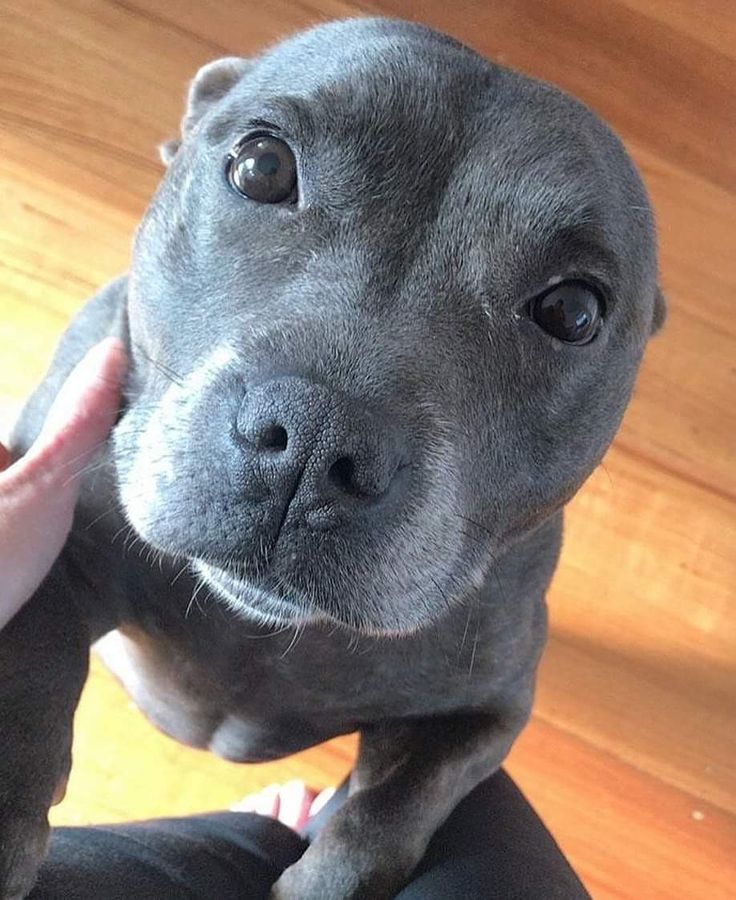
left=360, top=0, right=736, bottom=190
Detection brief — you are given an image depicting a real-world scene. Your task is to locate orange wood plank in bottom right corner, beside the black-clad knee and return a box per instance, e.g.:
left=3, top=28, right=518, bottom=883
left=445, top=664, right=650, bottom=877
left=507, top=719, right=736, bottom=900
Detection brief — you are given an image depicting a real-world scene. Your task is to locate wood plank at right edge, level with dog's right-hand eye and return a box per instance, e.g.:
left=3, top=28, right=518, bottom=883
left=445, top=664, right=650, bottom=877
left=617, top=144, right=736, bottom=498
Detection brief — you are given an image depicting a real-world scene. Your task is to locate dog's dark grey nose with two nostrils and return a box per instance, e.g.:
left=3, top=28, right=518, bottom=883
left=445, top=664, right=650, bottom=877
left=237, top=377, right=406, bottom=524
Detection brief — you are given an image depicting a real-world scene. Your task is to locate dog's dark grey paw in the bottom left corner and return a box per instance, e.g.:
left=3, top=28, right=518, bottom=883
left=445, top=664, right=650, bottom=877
left=0, top=812, right=49, bottom=900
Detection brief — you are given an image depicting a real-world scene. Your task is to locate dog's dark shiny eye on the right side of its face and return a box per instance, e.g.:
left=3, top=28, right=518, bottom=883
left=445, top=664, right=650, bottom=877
left=530, top=281, right=603, bottom=344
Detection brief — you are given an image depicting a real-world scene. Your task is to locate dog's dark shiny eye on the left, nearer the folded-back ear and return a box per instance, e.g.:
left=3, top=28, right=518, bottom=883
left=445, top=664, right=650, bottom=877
left=227, top=134, right=296, bottom=203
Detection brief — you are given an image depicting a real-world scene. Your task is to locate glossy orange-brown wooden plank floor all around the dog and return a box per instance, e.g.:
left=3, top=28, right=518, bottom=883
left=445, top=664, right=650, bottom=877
left=0, top=0, right=736, bottom=900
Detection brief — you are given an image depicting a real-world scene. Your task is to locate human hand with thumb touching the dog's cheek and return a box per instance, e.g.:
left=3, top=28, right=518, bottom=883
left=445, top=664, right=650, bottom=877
left=0, top=338, right=127, bottom=628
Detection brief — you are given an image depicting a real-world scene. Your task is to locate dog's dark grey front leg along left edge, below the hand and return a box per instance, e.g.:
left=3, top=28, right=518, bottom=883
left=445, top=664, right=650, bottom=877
left=0, top=561, right=89, bottom=900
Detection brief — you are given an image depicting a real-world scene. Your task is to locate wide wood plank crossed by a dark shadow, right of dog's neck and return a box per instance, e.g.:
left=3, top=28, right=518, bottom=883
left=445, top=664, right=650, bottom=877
left=535, top=448, right=736, bottom=812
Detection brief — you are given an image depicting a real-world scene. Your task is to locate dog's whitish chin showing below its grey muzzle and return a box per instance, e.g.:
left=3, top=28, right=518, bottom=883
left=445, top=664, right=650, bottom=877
left=192, top=559, right=320, bottom=626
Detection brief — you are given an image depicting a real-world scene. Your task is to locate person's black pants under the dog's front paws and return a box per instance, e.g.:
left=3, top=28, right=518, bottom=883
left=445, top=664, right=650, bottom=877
left=30, top=772, right=588, bottom=900
